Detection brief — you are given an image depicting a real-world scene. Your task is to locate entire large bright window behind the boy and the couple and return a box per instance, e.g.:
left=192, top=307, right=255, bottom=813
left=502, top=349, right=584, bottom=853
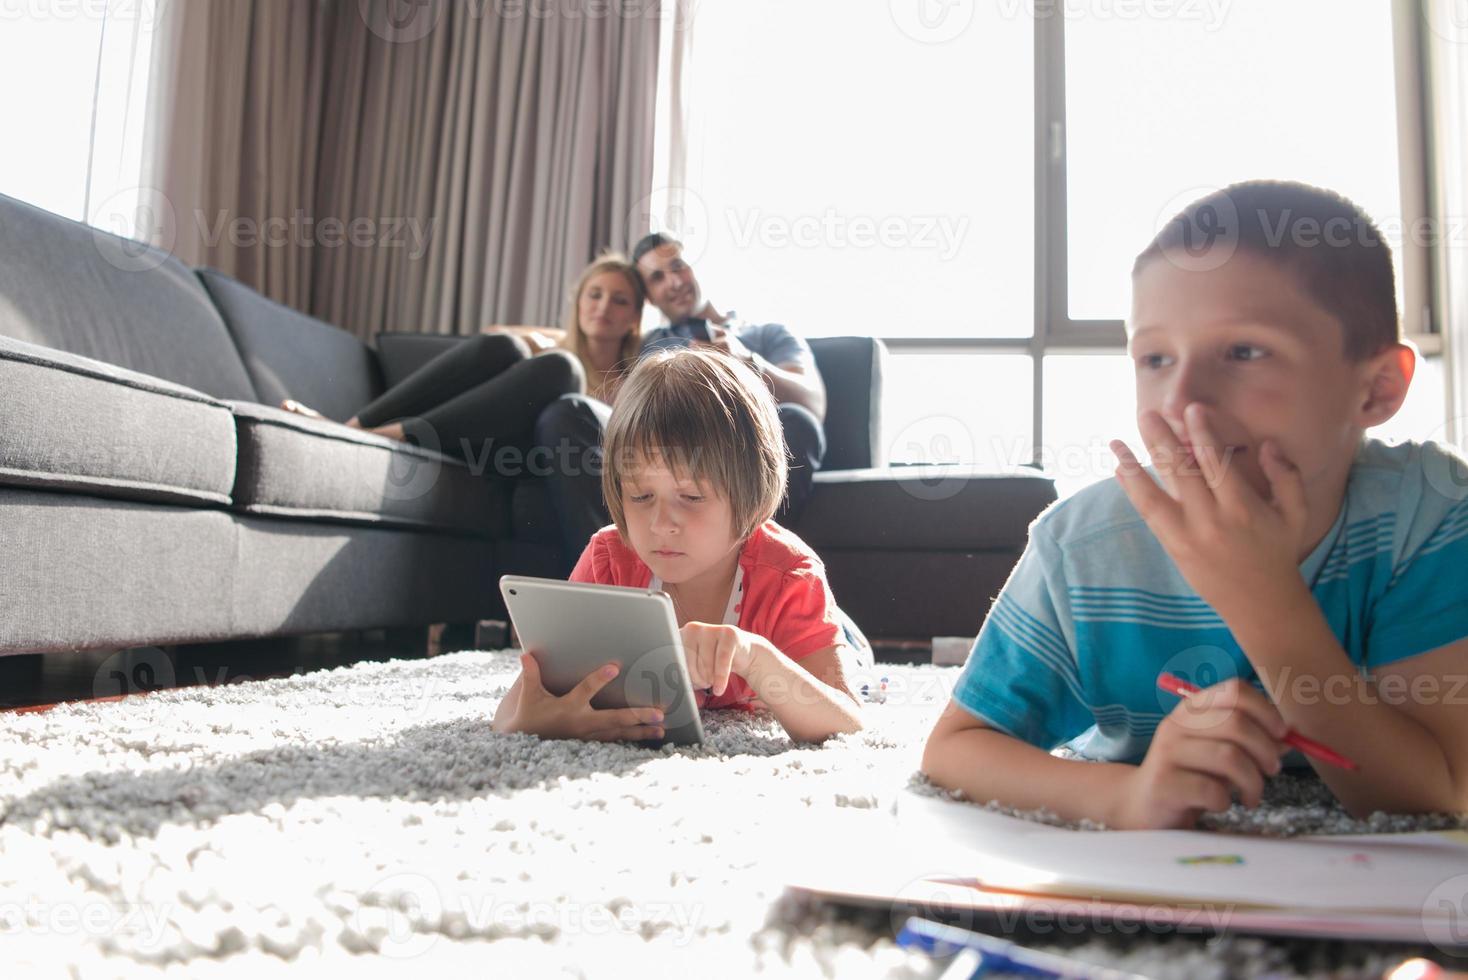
left=664, top=0, right=1446, bottom=493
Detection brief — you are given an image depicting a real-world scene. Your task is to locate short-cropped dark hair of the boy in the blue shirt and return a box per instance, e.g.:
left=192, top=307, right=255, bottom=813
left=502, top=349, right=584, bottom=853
left=1132, top=180, right=1400, bottom=361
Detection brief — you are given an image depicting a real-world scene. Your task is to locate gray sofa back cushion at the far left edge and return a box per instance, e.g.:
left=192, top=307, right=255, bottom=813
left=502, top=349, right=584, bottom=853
left=0, top=195, right=257, bottom=401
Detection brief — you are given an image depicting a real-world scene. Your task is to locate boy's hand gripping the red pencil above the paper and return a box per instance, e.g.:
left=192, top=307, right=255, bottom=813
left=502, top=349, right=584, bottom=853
left=1108, top=678, right=1289, bottom=829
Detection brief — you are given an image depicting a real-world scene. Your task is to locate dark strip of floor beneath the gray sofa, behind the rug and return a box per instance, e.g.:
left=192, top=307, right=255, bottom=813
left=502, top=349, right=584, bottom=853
left=0, top=624, right=931, bottom=710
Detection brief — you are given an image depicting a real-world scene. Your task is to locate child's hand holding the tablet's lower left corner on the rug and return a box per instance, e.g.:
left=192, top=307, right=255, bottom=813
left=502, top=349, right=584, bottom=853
left=493, top=653, right=664, bottom=742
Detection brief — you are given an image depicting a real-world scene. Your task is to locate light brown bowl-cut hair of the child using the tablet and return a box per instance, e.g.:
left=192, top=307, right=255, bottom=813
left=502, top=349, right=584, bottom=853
left=602, top=349, right=787, bottom=541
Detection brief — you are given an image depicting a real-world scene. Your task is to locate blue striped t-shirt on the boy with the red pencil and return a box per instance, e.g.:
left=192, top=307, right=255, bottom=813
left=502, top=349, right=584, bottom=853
left=953, top=440, right=1468, bottom=761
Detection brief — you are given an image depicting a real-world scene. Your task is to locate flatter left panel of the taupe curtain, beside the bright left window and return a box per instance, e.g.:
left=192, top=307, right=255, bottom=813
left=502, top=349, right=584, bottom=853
left=144, top=0, right=333, bottom=310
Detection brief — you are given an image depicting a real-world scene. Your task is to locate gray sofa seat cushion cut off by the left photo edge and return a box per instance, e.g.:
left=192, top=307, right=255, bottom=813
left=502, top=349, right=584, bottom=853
left=0, top=337, right=235, bottom=505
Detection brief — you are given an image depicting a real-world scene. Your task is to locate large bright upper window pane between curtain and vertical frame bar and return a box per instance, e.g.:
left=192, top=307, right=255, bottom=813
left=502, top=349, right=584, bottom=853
left=674, top=0, right=1035, bottom=337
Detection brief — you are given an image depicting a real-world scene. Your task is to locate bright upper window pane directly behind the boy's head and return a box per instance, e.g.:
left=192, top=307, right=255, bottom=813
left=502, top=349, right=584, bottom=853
left=1064, top=0, right=1402, bottom=320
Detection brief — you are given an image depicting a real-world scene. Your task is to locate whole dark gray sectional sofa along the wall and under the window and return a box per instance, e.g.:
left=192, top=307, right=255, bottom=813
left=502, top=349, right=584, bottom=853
left=0, top=187, right=1054, bottom=654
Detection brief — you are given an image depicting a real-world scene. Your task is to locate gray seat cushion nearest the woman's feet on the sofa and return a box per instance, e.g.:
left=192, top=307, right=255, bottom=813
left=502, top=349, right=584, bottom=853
left=230, top=402, right=505, bottom=535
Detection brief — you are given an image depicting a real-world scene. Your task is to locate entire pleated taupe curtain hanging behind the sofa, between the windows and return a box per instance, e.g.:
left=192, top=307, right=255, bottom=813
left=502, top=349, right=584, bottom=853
left=150, top=0, right=671, bottom=339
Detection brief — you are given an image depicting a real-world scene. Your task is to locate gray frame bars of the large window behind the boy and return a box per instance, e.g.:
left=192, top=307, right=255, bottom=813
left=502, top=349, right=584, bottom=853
left=882, top=0, right=1446, bottom=465
